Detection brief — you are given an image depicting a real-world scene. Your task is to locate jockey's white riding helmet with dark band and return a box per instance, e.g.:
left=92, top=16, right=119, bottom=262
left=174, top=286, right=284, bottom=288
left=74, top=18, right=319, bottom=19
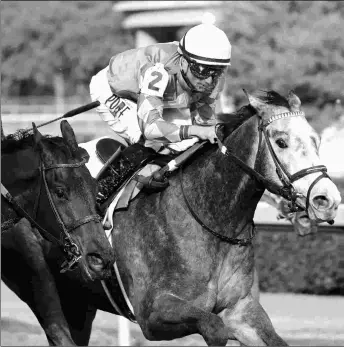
left=179, top=24, right=232, bottom=66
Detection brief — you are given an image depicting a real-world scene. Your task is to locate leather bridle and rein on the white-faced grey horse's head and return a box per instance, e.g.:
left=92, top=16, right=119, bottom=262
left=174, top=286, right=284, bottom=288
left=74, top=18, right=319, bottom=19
left=218, top=111, right=331, bottom=213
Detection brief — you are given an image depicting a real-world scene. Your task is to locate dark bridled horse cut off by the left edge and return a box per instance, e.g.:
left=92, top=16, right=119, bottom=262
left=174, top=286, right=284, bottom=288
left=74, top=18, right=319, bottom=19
left=1, top=121, right=114, bottom=345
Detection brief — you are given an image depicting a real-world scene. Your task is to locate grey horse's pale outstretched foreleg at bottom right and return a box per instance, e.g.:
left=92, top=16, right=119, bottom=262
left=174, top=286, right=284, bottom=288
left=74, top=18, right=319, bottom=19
left=219, top=295, right=288, bottom=346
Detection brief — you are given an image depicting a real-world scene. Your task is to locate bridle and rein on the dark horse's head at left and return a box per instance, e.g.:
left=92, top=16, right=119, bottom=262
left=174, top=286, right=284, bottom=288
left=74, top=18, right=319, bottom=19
left=1, top=158, right=101, bottom=272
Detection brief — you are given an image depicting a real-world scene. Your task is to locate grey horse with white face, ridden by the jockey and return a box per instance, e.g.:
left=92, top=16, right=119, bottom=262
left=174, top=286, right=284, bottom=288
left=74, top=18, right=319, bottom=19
left=24, top=91, right=341, bottom=346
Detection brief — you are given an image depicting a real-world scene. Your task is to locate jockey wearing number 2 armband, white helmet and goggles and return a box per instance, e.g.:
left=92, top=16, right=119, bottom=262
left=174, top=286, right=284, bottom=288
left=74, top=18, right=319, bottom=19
left=90, top=24, right=231, bottom=154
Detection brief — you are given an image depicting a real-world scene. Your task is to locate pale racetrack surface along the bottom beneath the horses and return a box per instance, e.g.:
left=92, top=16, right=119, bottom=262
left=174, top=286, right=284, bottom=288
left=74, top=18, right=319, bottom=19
left=1, top=283, right=344, bottom=346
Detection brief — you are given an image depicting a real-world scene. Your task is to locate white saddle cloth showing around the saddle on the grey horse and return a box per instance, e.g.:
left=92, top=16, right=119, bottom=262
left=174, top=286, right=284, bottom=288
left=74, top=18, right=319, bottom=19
left=79, top=136, right=161, bottom=245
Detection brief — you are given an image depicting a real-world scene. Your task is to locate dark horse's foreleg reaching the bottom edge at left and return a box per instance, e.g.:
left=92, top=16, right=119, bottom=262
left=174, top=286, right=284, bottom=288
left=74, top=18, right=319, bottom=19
left=11, top=218, right=75, bottom=346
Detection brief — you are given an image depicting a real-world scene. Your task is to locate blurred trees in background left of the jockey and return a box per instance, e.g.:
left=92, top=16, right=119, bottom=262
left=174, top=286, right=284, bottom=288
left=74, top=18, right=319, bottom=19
left=1, top=1, right=133, bottom=96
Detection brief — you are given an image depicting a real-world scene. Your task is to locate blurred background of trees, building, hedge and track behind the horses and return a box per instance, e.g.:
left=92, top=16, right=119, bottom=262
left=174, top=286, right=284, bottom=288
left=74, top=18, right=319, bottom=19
left=0, top=1, right=344, bottom=345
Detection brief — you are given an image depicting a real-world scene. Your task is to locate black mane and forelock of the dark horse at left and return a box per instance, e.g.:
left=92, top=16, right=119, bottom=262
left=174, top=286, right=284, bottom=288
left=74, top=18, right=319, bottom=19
left=1, top=129, right=63, bottom=154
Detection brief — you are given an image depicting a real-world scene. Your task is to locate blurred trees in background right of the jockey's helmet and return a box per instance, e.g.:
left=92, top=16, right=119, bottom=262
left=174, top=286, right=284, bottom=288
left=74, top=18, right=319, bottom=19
left=220, top=1, right=344, bottom=114
